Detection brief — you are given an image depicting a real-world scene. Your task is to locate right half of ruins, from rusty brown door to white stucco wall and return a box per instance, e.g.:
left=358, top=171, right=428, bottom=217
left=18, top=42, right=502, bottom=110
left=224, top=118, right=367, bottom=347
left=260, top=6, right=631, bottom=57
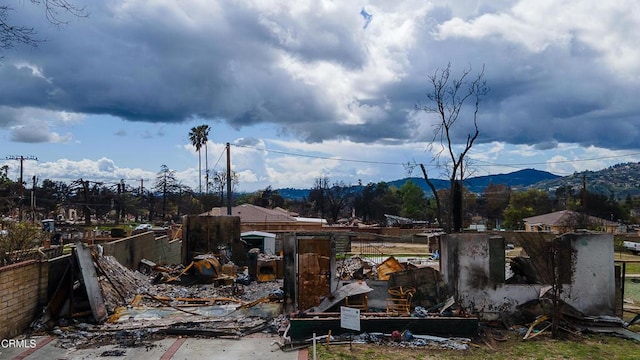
left=284, top=232, right=640, bottom=340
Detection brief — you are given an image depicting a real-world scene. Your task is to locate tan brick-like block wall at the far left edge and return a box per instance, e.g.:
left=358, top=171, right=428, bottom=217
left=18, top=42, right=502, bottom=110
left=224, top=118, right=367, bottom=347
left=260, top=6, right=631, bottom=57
left=0, top=260, right=49, bottom=339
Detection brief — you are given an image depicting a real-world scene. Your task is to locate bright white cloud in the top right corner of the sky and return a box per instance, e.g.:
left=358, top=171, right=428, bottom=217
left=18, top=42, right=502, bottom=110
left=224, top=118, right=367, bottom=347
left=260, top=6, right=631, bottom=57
left=438, top=0, right=640, bottom=80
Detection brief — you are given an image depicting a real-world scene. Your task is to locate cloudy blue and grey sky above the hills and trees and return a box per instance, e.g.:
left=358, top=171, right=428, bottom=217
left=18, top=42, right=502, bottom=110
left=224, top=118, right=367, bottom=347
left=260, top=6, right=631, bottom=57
left=0, top=0, right=640, bottom=191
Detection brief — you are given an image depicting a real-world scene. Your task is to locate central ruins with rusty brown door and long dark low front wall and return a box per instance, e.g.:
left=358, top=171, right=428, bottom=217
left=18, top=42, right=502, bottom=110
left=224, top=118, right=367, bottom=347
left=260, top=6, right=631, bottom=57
left=284, top=233, right=478, bottom=341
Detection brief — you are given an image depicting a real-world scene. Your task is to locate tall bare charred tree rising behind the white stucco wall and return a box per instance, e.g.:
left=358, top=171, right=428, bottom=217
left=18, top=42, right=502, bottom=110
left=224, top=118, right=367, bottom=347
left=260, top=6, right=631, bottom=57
left=418, top=64, right=489, bottom=232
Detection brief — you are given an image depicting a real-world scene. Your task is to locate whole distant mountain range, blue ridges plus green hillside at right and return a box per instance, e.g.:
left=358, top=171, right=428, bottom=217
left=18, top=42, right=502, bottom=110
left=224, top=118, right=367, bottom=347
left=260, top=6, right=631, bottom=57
left=278, top=162, right=640, bottom=200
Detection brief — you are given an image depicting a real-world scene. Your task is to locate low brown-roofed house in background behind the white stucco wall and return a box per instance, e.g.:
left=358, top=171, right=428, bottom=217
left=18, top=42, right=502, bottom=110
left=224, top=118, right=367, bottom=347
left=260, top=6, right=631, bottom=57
left=523, top=210, right=619, bottom=234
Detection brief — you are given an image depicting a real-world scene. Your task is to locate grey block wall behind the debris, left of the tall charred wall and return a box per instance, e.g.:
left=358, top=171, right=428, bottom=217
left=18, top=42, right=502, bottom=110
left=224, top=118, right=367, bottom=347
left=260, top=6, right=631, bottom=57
left=102, top=231, right=182, bottom=270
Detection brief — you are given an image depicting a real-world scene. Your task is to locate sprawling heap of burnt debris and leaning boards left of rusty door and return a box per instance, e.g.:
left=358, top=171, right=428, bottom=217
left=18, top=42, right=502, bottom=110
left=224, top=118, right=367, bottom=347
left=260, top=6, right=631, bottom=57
left=32, top=242, right=284, bottom=348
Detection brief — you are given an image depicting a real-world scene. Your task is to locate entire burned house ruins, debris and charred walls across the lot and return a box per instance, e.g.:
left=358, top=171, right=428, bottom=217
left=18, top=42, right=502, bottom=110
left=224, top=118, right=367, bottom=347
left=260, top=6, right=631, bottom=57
left=7, top=217, right=640, bottom=351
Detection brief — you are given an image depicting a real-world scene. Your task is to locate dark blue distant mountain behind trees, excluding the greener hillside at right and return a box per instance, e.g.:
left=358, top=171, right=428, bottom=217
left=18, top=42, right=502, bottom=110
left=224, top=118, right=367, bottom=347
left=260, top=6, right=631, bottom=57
left=278, top=169, right=560, bottom=200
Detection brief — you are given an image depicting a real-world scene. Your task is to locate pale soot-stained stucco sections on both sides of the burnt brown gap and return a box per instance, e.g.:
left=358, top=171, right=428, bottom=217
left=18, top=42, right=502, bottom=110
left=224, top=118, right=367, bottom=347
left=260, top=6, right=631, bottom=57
left=441, top=233, right=615, bottom=319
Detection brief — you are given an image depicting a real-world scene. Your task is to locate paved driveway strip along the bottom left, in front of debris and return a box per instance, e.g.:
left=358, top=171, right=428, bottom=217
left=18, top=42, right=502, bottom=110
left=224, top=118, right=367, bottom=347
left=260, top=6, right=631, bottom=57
left=0, top=334, right=307, bottom=360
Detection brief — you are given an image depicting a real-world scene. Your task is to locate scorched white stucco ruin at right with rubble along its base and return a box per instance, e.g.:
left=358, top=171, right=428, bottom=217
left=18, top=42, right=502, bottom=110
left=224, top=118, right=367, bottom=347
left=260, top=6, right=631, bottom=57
left=441, top=231, right=640, bottom=341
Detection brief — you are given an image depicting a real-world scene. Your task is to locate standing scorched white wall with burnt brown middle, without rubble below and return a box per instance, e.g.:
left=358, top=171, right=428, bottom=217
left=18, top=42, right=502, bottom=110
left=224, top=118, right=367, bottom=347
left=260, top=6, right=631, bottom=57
left=441, top=233, right=615, bottom=320
